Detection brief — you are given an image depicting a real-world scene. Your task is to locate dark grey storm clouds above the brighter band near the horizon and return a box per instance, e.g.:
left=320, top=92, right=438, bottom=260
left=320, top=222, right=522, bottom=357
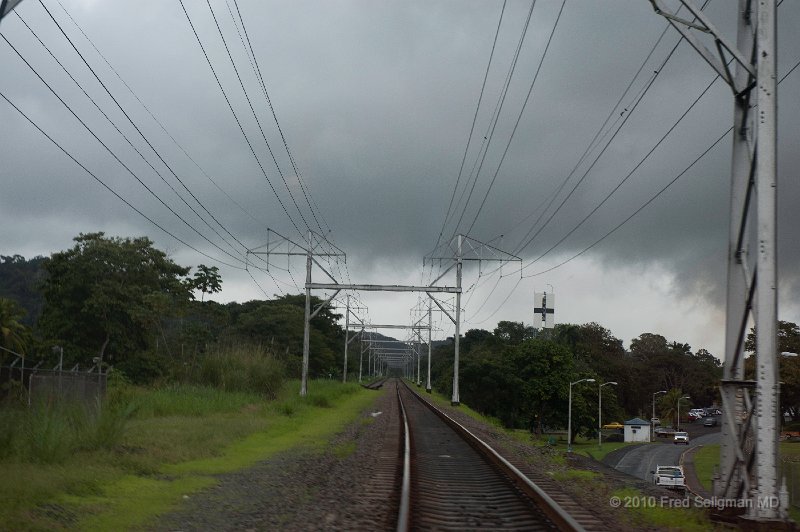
left=0, top=0, right=800, bottom=348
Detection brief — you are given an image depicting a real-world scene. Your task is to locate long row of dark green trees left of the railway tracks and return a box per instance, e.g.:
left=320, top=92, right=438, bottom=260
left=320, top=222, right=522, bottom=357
left=0, top=233, right=344, bottom=383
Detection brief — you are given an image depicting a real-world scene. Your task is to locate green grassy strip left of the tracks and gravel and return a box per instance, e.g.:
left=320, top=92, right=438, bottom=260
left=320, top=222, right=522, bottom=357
left=0, top=381, right=382, bottom=530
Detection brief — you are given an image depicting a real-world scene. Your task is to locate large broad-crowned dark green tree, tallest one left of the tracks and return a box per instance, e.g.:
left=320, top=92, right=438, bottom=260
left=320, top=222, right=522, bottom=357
left=40, top=233, right=189, bottom=379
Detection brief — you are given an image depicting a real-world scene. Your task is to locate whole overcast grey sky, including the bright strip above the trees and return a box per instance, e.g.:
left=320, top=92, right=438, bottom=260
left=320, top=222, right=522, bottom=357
left=0, top=0, right=800, bottom=357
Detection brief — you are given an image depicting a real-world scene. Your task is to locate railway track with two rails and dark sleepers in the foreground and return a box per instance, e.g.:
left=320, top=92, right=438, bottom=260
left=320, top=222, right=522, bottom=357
left=397, top=384, right=591, bottom=531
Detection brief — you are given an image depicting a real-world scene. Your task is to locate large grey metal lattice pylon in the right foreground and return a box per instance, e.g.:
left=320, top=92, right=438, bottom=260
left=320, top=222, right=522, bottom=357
left=650, top=0, right=788, bottom=526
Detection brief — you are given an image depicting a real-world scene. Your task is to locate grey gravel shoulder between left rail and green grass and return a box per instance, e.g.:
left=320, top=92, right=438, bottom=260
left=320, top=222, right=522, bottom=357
left=148, top=390, right=397, bottom=531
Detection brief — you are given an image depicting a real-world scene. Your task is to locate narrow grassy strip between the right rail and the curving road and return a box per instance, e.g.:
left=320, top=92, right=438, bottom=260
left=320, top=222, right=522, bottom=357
left=417, top=380, right=713, bottom=531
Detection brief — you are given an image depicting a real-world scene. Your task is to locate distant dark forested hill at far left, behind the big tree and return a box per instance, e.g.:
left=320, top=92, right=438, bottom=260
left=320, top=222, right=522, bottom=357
left=0, top=255, right=45, bottom=326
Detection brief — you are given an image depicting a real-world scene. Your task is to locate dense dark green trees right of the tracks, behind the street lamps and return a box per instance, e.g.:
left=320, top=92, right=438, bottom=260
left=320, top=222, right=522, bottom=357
left=433, top=322, right=721, bottom=440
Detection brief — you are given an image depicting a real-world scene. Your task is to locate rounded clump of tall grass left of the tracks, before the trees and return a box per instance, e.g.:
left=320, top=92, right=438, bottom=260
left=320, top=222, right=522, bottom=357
left=197, top=345, right=283, bottom=399
